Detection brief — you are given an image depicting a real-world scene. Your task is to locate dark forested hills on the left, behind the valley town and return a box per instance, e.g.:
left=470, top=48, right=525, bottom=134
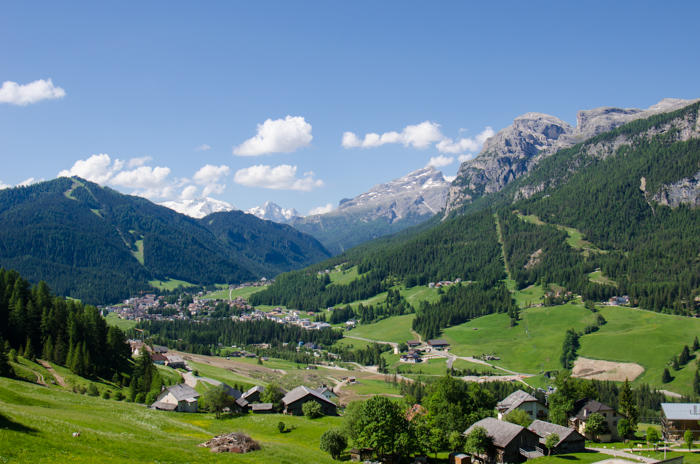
left=0, top=178, right=329, bottom=303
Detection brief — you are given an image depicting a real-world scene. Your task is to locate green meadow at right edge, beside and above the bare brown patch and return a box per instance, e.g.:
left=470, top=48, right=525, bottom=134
left=579, top=306, right=700, bottom=395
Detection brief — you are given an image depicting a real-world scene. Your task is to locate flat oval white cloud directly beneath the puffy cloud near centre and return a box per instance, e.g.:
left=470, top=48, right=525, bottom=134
left=233, top=164, right=323, bottom=192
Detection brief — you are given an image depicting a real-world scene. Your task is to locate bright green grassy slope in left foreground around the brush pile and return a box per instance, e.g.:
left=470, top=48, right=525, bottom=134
left=0, top=379, right=341, bottom=464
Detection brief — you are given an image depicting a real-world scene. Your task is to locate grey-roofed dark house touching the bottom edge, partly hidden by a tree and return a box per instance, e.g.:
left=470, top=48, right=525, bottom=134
left=463, top=417, right=544, bottom=463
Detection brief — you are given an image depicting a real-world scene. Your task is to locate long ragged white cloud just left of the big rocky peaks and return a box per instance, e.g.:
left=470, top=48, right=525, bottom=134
left=341, top=121, right=494, bottom=155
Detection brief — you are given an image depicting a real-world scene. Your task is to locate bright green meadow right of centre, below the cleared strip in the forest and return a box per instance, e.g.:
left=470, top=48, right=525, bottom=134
left=443, top=304, right=593, bottom=374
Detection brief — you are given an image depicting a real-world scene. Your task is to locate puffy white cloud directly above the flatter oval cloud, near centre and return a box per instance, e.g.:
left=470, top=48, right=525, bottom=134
left=233, top=116, right=313, bottom=156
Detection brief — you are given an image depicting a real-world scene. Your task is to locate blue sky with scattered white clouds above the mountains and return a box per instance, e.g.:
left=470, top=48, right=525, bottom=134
left=0, top=1, right=700, bottom=214
